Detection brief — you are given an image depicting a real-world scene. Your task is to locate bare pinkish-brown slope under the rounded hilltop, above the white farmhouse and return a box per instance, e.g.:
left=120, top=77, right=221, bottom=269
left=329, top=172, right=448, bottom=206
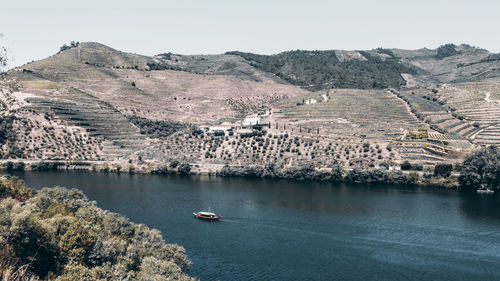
left=18, top=43, right=305, bottom=123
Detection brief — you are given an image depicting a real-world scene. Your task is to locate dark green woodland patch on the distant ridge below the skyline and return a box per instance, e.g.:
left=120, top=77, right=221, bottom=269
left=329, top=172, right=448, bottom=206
left=226, top=50, right=415, bottom=90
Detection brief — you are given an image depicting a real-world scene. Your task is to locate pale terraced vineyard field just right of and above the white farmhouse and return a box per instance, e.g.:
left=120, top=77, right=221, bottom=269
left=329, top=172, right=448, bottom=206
left=273, top=90, right=427, bottom=140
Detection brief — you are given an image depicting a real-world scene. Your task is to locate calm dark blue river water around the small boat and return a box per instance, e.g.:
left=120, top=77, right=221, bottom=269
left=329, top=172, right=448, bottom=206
left=8, top=172, right=500, bottom=280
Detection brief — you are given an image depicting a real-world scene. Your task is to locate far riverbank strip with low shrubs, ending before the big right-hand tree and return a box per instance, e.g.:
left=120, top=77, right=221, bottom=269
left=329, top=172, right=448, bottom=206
left=0, top=160, right=460, bottom=189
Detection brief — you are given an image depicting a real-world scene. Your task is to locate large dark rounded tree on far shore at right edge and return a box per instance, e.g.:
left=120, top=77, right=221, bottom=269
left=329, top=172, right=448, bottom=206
left=459, top=145, right=500, bottom=189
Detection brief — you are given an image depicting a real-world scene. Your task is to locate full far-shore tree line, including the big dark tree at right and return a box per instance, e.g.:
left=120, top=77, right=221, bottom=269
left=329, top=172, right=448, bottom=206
left=0, top=145, right=500, bottom=189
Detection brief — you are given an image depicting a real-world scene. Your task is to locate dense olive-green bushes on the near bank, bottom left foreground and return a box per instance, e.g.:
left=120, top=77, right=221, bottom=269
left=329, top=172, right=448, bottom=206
left=0, top=176, right=192, bottom=281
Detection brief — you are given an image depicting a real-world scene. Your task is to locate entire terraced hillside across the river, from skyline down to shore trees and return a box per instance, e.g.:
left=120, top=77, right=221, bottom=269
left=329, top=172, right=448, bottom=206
left=0, top=42, right=500, bottom=172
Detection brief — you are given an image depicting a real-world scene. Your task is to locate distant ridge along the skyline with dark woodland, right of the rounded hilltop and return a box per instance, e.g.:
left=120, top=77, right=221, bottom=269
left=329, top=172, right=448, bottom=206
left=142, top=44, right=500, bottom=91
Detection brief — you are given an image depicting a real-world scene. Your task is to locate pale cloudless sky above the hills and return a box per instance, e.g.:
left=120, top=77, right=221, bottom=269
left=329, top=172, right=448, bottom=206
left=0, top=0, right=500, bottom=66
